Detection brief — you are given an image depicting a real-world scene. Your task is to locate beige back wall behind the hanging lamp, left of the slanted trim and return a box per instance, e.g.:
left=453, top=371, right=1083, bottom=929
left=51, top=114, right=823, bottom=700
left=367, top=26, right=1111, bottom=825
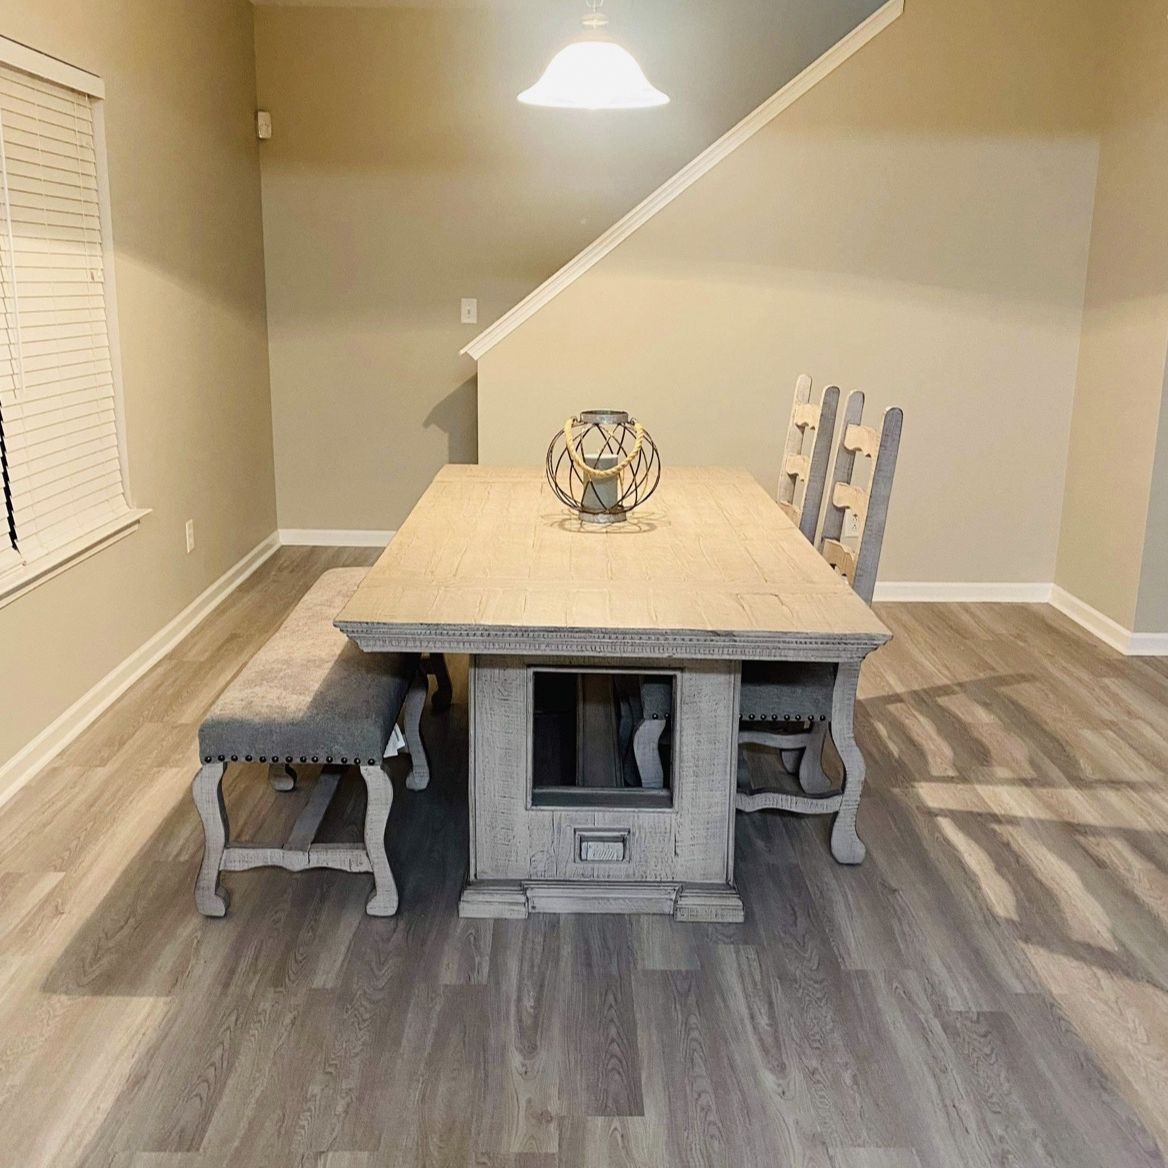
left=256, top=0, right=878, bottom=529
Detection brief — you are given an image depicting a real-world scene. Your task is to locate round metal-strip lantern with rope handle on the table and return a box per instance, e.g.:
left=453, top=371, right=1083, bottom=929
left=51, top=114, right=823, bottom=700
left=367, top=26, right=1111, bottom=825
left=547, top=410, right=661, bottom=523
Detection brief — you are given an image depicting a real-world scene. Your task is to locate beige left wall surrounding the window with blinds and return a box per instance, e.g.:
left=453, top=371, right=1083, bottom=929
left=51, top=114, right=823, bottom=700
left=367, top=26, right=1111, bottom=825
left=0, top=0, right=276, bottom=766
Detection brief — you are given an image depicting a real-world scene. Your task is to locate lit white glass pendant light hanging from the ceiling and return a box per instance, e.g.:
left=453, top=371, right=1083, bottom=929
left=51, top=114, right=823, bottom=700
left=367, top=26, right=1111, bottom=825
left=519, top=0, right=669, bottom=110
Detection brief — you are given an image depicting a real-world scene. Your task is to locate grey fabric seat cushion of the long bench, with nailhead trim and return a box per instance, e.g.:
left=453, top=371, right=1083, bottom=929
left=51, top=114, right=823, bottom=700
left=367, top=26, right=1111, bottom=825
left=199, top=568, right=418, bottom=765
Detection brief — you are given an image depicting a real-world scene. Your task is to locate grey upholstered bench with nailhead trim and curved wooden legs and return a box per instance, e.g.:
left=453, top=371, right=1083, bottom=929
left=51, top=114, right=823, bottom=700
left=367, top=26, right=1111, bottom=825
left=193, top=568, right=430, bottom=917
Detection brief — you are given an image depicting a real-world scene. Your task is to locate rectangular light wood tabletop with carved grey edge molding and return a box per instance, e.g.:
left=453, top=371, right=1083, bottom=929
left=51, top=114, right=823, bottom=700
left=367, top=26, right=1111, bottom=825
left=336, top=466, right=890, bottom=661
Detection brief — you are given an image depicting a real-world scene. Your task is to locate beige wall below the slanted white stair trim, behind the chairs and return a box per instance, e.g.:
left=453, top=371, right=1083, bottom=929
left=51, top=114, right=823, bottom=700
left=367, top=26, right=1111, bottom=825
left=479, top=0, right=1098, bottom=583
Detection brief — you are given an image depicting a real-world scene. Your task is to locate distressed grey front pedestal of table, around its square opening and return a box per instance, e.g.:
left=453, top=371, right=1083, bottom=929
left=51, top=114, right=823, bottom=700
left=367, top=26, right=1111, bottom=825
left=459, top=655, right=743, bottom=920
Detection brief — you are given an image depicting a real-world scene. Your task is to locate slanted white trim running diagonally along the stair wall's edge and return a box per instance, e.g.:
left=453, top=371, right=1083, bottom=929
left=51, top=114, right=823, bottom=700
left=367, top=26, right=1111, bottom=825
left=461, top=0, right=904, bottom=361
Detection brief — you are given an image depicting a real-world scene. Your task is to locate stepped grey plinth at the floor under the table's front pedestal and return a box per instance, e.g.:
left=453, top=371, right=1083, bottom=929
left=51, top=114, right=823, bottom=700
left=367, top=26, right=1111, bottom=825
left=458, top=880, right=744, bottom=924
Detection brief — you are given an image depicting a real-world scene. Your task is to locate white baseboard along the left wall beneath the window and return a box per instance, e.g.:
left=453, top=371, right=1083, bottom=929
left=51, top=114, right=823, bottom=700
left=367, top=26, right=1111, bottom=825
left=0, top=531, right=280, bottom=806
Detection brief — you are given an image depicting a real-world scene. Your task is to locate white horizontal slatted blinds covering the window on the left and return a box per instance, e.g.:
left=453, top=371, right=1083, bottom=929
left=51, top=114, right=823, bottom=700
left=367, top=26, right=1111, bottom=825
left=0, top=59, right=128, bottom=571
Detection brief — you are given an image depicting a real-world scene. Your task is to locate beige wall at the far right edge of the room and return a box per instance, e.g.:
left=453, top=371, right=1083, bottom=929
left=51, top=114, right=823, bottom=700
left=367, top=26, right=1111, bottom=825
left=1056, top=0, right=1168, bottom=632
